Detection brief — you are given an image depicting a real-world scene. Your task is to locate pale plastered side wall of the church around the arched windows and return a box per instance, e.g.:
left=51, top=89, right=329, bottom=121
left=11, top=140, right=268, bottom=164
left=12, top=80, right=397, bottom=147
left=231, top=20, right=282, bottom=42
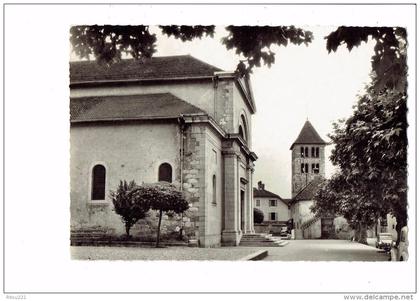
left=70, top=120, right=180, bottom=234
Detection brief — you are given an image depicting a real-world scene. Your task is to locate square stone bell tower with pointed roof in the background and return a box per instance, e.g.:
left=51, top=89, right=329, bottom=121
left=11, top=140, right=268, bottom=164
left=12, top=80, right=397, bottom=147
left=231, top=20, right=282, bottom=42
left=290, top=120, right=327, bottom=198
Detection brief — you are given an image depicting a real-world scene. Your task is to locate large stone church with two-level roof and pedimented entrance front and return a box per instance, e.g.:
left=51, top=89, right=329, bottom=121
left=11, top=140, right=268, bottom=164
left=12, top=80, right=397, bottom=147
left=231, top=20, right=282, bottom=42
left=70, top=55, right=257, bottom=247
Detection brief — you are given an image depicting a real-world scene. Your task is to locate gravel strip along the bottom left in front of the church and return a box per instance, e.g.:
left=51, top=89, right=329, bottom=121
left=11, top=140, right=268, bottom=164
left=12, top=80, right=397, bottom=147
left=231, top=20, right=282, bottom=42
left=71, top=247, right=265, bottom=260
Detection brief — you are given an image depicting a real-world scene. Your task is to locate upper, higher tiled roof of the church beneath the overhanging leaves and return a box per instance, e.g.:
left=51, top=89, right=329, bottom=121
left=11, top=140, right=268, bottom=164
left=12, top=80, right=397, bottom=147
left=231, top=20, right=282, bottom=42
left=70, top=55, right=222, bottom=84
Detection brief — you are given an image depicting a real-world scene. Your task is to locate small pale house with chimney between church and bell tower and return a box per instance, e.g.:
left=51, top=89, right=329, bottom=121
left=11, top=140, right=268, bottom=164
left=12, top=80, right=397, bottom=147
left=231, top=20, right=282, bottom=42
left=254, top=181, right=290, bottom=223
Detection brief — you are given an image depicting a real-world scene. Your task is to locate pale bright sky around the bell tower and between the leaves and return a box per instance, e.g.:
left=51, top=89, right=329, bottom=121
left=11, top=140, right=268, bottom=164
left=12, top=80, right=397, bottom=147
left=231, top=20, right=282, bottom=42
left=156, top=26, right=373, bottom=198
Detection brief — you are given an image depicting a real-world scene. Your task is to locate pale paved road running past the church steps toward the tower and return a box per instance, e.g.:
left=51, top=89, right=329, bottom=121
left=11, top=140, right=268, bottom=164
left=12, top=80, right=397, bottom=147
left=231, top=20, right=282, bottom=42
left=264, top=239, right=389, bottom=261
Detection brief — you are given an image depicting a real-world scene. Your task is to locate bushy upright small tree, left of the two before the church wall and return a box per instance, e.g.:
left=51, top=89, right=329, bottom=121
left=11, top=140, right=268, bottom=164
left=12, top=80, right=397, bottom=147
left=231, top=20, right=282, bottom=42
left=110, top=180, right=150, bottom=237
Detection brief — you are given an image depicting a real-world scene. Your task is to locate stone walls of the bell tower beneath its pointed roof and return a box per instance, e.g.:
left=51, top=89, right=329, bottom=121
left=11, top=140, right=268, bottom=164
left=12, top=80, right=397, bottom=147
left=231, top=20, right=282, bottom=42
left=292, top=144, right=325, bottom=197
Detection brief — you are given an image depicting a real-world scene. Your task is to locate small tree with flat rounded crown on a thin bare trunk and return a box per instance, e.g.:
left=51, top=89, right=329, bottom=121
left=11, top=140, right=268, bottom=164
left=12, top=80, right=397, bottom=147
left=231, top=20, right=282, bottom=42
left=142, top=182, right=189, bottom=247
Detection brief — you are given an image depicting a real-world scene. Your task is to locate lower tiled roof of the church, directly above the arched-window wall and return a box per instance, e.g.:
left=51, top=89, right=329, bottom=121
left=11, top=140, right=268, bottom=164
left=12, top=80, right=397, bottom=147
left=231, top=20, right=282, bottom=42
left=70, top=93, right=204, bottom=122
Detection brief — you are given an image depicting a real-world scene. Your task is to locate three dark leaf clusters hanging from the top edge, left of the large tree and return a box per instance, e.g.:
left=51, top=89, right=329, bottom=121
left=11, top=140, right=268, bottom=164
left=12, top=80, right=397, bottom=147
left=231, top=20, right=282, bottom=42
left=70, top=25, right=313, bottom=75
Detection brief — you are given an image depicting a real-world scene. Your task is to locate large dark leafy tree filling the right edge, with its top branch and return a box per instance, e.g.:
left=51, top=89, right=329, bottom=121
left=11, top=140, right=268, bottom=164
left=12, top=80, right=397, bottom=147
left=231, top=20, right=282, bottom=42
left=313, top=27, right=408, bottom=244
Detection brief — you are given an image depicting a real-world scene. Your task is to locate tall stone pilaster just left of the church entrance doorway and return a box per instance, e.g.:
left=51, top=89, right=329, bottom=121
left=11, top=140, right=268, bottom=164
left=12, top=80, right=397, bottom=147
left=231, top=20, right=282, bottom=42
left=222, top=149, right=240, bottom=246
